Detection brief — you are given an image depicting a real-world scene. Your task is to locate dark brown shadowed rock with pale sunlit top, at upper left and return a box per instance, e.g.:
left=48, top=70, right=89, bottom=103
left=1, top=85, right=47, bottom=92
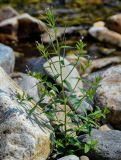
left=0, top=13, right=46, bottom=41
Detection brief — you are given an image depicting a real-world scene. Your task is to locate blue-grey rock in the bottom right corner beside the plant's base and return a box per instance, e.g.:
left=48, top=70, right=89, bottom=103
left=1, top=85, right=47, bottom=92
left=79, top=130, right=121, bottom=160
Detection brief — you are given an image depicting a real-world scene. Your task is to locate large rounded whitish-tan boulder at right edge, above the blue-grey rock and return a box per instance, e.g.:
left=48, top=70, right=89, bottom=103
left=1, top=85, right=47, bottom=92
left=95, top=65, right=121, bottom=128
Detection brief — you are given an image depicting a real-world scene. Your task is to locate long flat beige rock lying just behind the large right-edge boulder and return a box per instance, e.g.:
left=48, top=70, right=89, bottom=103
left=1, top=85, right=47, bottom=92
left=86, top=56, right=121, bottom=73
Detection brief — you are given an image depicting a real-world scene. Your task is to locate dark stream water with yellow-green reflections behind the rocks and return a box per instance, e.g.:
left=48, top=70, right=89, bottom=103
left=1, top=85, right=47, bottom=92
left=0, top=0, right=121, bottom=71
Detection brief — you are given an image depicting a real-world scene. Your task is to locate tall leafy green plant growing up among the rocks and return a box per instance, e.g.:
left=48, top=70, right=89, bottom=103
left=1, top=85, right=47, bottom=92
left=22, top=10, right=108, bottom=159
